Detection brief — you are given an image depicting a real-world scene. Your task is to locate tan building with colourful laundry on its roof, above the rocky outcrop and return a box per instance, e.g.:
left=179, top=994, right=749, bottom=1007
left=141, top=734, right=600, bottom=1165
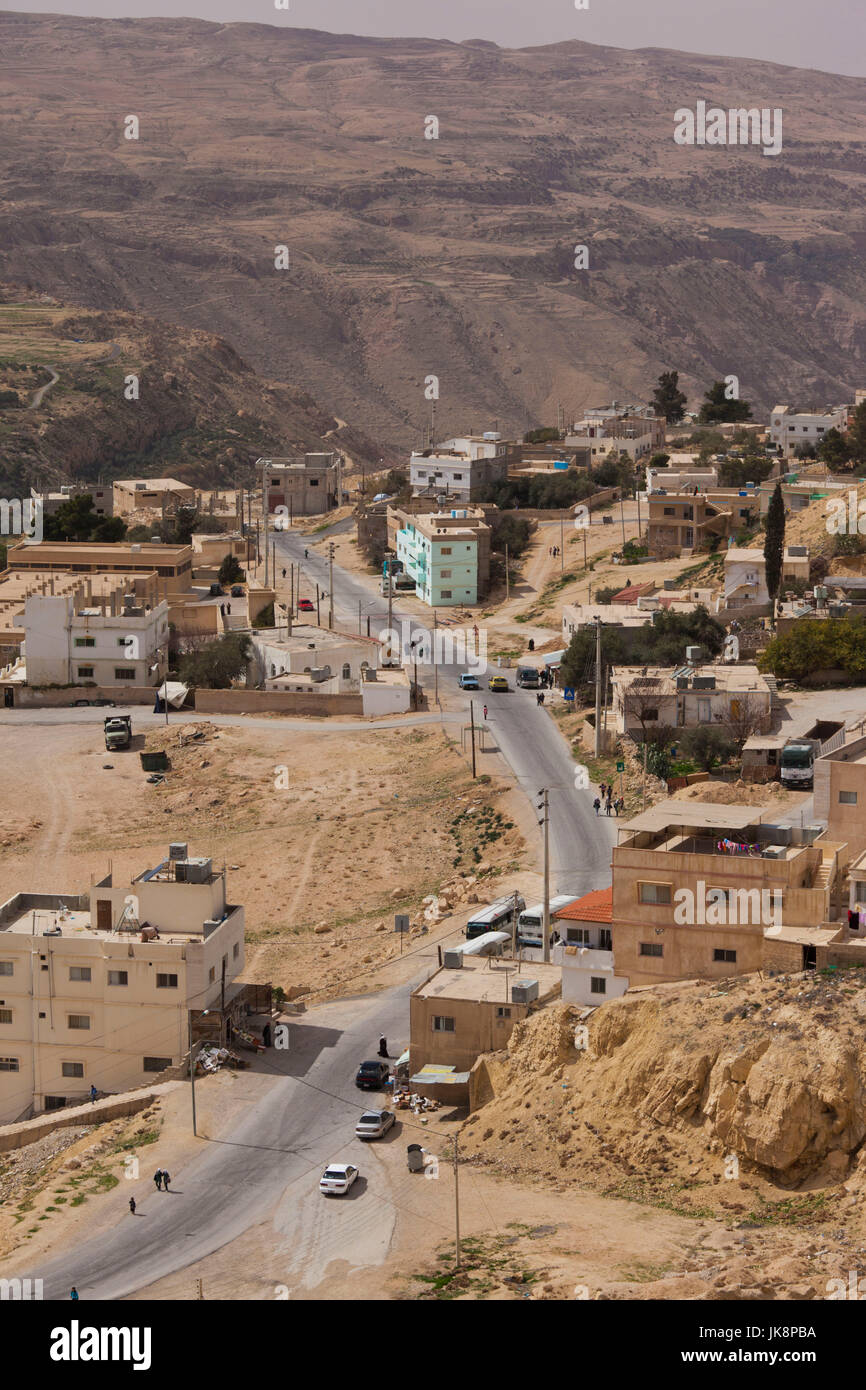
left=612, top=801, right=848, bottom=987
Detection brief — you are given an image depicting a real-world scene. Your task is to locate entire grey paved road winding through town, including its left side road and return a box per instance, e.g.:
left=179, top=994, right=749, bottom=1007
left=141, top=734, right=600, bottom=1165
left=20, top=519, right=616, bottom=1298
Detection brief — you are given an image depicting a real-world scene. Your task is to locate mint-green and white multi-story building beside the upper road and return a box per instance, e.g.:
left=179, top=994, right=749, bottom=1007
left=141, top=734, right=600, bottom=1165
left=388, top=507, right=491, bottom=607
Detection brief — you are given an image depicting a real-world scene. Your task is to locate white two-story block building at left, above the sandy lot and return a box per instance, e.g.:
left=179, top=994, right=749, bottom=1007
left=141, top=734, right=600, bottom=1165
left=24, top=591, right=168, bottom=687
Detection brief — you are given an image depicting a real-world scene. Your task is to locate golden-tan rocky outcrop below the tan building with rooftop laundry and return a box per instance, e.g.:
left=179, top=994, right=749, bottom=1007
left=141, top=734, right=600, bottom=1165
left=461, top=969, right=866, bottom=1206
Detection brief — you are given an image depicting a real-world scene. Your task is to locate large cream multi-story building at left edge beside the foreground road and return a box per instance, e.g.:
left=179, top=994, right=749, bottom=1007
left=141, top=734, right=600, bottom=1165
left=0, top=844, right=243, bottom=1123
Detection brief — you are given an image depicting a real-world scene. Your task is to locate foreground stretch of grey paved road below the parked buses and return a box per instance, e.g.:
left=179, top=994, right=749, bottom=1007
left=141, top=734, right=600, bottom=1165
left=27, top=978, right=435, bottom=1301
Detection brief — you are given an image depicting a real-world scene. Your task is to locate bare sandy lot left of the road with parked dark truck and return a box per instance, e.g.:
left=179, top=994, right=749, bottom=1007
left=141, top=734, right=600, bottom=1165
left=0, top=723, right=525, bottom=992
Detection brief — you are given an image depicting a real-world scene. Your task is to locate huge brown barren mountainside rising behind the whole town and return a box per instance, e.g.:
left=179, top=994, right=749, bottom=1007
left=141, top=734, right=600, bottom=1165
left=0, top=13, right=866, bottom=450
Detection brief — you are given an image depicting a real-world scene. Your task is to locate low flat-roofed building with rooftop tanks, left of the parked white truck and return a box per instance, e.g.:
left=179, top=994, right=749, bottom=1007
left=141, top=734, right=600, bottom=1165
left=610, top=663, right=773, bottom=742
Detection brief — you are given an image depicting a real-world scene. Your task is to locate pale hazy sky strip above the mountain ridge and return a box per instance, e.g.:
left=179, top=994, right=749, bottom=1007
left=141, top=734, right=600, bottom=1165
left=8, top=0, right=866, bottom=76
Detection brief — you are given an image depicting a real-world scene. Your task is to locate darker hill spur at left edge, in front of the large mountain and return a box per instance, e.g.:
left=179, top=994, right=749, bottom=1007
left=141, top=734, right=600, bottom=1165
left=0, top=286, right=377, bottom=495
